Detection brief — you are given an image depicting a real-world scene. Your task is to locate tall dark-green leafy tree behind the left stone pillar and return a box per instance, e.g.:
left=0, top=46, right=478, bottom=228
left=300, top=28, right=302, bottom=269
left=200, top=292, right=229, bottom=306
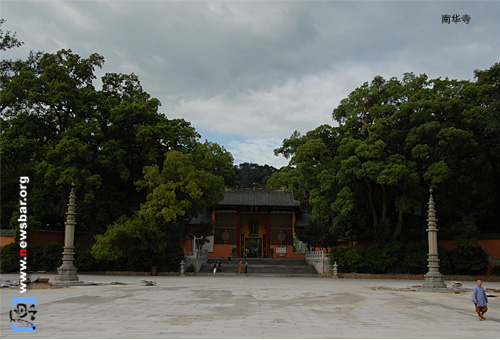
left=0, top=50, right=199, bottom=239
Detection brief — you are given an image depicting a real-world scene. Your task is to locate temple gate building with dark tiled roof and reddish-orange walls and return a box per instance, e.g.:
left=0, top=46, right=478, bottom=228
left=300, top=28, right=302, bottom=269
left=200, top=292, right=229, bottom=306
left=183, top=189, right=310, bottom=258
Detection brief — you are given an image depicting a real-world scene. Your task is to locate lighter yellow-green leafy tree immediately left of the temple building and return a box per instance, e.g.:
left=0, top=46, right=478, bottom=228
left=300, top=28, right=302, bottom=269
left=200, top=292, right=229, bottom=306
left=92, top=142, right=233, bottom=263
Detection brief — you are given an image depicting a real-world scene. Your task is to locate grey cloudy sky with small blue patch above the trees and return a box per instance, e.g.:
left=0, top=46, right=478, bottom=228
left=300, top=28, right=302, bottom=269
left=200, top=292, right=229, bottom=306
left=0, top=0, right=500, bottom=167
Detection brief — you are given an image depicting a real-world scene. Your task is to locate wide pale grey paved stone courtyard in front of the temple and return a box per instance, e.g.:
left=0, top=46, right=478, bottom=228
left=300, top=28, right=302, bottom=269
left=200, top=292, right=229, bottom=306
left=0, top=275, right=500, bottom=338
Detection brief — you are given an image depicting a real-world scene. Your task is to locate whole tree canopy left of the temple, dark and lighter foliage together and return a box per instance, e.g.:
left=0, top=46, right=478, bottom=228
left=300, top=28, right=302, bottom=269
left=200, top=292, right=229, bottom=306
left=0, top=22, right=235, bottom=266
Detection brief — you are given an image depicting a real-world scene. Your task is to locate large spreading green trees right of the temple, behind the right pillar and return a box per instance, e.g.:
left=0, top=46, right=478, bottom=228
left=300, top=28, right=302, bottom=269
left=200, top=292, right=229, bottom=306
left=268, top=65, right=499, bottom=247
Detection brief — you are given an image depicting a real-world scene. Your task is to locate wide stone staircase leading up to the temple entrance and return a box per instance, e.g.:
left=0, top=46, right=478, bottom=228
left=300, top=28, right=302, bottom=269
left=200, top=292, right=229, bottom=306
left=196, top=257, right=318, bottom=277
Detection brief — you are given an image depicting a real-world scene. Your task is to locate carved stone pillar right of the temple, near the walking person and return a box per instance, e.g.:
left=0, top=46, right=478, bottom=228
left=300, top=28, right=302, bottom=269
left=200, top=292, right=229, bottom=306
left=424, top=188, right=446, bottom=288
